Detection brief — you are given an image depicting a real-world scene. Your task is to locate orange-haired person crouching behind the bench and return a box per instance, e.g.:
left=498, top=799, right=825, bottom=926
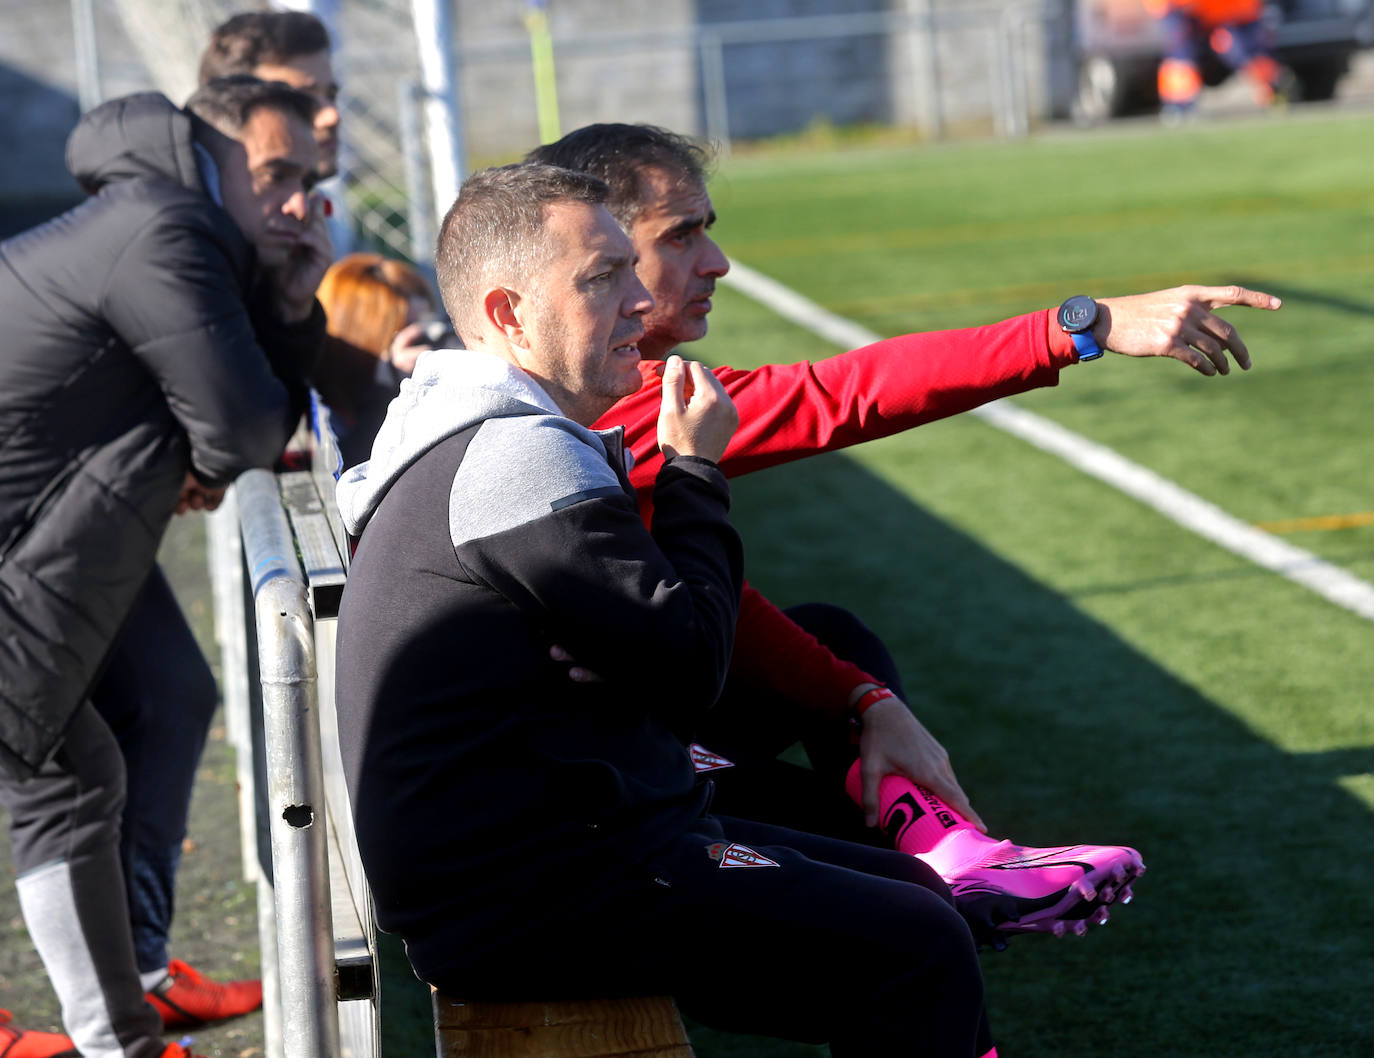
left=313, top=253, right=456, bottom=466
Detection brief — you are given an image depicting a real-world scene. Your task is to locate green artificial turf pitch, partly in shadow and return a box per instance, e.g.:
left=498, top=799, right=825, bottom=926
left=692, top=111, right=1374, bottom=1058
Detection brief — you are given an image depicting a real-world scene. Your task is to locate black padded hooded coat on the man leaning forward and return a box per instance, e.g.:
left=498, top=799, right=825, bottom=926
left=0, top=93, right=324, bottom=776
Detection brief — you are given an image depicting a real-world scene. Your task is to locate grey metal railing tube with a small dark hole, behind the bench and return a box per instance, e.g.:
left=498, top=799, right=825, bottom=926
left=236, top=470, right=339, bottom=1058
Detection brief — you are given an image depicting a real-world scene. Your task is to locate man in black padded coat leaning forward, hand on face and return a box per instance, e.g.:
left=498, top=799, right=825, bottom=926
left=0, top=78, right=330, bottom=1058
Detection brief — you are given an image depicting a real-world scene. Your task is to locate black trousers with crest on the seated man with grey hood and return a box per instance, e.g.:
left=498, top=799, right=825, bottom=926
left=433, top=816, right=992, bottom=1058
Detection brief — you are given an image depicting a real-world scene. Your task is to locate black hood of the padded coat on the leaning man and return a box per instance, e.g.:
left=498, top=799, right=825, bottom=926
left=67, top=92, right=206, bottom=194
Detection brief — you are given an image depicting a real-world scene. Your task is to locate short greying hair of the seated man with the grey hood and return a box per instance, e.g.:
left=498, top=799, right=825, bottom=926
left=436, top=164, right=610, bottom=345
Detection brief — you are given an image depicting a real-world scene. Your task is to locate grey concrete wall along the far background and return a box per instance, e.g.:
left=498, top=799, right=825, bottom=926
left=0, top=0, right=1068, bottom=218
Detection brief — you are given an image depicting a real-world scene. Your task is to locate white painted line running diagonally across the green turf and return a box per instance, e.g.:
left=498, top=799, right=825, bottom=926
left=721, top=261, right=1374, bottom=621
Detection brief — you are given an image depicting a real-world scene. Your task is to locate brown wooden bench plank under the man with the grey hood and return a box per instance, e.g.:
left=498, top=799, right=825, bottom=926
left=434, top=992, right=692, bottom=1058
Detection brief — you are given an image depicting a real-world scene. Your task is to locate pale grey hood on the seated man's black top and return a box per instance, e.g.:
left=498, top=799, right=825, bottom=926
left=337, top=349, right=620, bottom=537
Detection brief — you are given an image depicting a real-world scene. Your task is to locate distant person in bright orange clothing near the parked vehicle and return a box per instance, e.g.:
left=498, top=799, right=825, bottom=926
left=1146, top=0, right=1289, bottom=118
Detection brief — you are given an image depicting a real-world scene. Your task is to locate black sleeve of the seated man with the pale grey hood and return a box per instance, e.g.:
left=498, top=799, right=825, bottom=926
left=455, top=423, right=743, bottom=721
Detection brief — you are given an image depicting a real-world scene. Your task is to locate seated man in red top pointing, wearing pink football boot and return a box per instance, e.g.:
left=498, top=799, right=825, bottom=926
left=528, top=125, right=1278, bottom=943
